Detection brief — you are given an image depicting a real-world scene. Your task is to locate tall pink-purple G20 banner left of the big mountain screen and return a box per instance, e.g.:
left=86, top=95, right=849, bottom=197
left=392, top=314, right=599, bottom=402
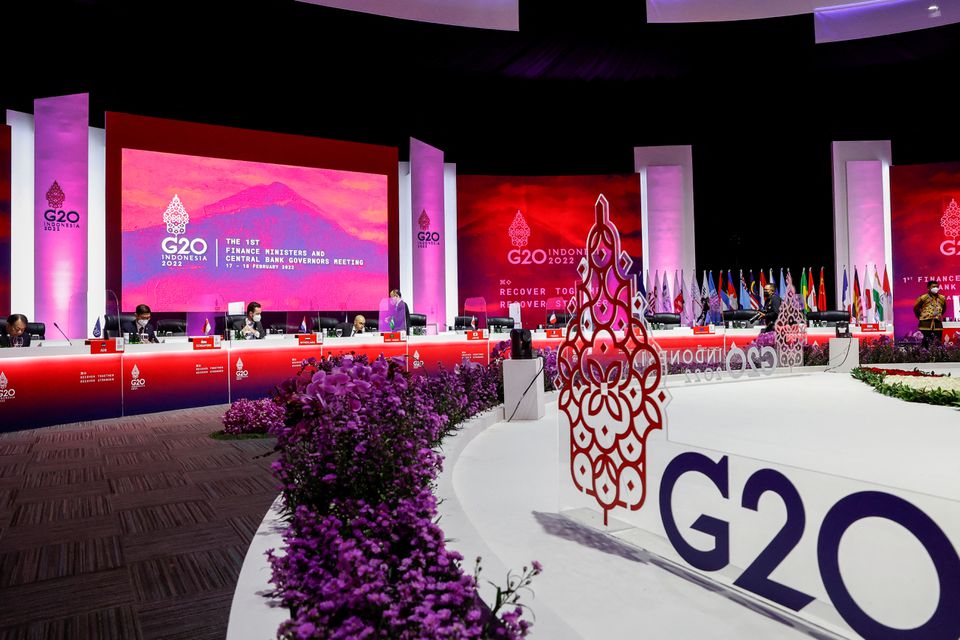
left=30, top=93, right=90, bottom=338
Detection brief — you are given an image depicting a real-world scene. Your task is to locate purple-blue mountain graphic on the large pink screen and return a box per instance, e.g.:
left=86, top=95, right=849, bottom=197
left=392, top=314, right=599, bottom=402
left=122, top=182, right=388, bottom=310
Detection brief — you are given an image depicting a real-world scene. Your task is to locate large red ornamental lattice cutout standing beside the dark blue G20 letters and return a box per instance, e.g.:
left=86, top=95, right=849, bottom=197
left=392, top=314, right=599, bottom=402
left=557, top=195, right=668, bottom=523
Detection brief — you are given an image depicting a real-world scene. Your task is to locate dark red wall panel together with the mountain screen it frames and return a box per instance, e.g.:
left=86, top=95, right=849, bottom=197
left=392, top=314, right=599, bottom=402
left=106, top=113, right=399, bottom=312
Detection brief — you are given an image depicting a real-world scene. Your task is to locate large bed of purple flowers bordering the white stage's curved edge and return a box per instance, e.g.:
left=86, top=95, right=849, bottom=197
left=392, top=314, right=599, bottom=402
left=269, top=357, right=540, bottom=639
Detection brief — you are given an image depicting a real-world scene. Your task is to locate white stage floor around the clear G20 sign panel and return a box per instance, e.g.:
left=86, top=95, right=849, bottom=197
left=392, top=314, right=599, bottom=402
left=438, top=367, right=960, bottom=639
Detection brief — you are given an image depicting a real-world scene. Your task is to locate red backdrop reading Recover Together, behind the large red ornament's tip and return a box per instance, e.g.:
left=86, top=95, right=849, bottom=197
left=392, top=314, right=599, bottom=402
left=457, top=174, right=643, bottom=327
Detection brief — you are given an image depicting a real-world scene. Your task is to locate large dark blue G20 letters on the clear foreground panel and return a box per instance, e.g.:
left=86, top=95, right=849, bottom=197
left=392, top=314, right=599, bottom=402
left=660, top=451, right=960, bottom=640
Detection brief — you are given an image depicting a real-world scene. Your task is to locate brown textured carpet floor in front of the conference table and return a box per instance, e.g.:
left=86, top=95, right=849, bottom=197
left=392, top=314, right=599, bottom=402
left=0, top=408, right=278, bottom=640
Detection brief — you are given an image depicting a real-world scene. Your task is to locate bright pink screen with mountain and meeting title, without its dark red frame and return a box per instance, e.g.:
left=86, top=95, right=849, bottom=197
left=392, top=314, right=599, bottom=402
left=122, top=149, right=388, bottom=311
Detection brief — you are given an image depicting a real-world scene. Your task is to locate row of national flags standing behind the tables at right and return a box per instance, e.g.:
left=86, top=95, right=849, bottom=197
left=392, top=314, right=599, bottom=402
left=638, top=265, right=893, bottom=326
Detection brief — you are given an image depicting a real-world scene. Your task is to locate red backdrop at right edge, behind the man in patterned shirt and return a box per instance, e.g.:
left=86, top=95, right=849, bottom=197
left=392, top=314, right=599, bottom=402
left=890, top=163, right=960, bottom=337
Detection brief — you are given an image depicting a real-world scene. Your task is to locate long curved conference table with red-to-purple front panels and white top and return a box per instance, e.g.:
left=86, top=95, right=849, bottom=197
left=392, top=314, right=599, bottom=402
left=0, top=328, right=892, bottom=431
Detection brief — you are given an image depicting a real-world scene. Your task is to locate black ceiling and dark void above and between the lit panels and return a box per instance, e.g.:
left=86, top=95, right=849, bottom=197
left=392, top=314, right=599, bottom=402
left=0, top=0, right=960, bottom=290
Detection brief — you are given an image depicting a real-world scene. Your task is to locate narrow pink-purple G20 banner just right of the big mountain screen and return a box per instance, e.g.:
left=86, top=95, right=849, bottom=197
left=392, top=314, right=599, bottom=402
left=410, top=138, right=447, bottom=331
